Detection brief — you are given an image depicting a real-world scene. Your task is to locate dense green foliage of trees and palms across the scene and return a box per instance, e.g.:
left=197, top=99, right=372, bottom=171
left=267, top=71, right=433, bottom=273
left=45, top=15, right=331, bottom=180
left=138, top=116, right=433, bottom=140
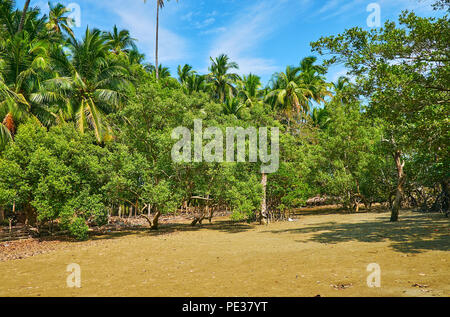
left=0, top=0, right=450, bottom=236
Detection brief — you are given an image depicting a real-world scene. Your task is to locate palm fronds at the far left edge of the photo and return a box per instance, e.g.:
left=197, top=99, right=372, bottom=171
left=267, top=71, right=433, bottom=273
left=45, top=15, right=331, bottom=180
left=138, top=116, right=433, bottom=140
left=0, top=0, right=52, bottom=145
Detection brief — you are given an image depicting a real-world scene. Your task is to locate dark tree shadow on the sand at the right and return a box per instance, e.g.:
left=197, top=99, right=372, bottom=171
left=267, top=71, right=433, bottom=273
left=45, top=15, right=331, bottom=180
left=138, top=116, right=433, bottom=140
left=264, top=214, right=450, bottom=253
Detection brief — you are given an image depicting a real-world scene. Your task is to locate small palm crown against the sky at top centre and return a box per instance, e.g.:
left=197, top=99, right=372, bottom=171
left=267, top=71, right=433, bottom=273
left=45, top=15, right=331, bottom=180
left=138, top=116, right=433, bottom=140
left=208, top=54, right=240, bottom=102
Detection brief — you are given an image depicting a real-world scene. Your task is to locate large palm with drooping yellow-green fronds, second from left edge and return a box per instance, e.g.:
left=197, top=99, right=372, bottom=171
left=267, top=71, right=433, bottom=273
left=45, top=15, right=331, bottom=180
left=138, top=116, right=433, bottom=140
left=32, top=28, right=130, bottom=142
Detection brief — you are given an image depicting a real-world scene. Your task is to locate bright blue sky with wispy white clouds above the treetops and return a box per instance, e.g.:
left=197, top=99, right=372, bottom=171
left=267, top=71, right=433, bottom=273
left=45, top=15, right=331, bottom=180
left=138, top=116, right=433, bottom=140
left=17, top=0, right=440, bottom=83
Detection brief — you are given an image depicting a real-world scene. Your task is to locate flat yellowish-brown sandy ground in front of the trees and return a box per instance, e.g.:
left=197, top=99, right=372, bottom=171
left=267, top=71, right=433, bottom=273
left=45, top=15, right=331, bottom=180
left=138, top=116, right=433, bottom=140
left=0, top=210, right=450, bottom=297
